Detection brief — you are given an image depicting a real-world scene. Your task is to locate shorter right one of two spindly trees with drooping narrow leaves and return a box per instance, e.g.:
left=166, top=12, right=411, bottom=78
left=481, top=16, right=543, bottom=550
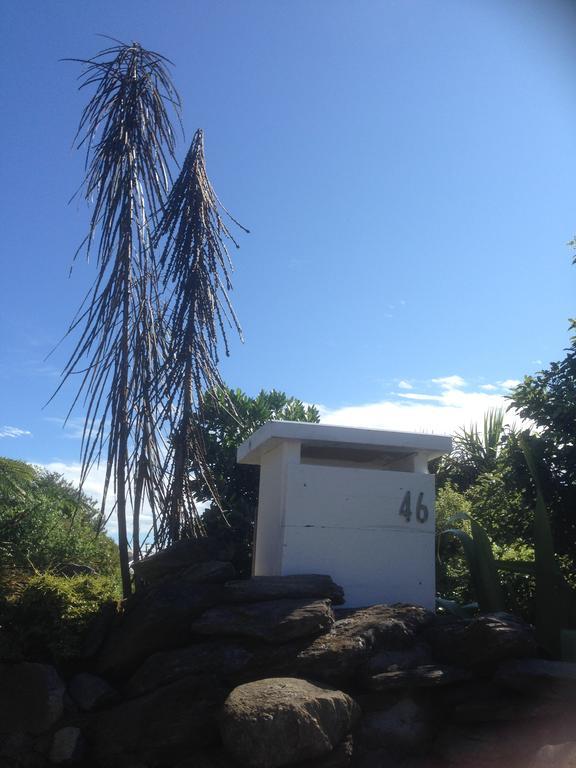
left=155, top=130, right=248, bottom=544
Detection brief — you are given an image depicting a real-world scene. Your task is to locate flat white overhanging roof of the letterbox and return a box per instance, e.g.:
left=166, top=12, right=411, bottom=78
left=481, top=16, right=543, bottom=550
left=236, top=421, right=452, bottom=464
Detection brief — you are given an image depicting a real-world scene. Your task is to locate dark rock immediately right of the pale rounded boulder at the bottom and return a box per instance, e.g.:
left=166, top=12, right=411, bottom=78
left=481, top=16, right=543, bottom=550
left=360, top=697, right=431, bottom=752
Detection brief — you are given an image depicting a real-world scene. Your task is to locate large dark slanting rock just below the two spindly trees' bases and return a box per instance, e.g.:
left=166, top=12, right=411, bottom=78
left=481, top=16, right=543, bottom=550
left=97, top=581, right=222, bottom=677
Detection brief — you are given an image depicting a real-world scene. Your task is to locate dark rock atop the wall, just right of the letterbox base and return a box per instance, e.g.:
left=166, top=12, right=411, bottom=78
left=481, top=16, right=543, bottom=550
left=427, top=613, right=536, bottom=666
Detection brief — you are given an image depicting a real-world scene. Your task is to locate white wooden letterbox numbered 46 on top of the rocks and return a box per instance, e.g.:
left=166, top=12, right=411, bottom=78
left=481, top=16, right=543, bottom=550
left=237, top=421, right=452, bottom=608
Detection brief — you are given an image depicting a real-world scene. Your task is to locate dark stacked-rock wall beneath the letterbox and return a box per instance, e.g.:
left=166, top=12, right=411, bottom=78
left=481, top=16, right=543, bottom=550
left=0, top=542, right=576, bottom=768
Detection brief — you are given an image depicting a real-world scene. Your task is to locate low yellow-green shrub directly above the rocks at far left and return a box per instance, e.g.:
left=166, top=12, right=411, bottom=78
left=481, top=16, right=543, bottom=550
left=2, top=573, right=120, bottom=660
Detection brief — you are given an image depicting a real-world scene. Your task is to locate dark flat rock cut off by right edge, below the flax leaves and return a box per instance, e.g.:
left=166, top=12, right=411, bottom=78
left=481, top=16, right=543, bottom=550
left=495, top=659, right=576, bottom=698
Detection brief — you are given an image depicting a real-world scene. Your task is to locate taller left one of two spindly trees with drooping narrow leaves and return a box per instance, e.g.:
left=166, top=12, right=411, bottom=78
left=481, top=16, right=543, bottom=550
left=53, top=43, right=179, bottom=594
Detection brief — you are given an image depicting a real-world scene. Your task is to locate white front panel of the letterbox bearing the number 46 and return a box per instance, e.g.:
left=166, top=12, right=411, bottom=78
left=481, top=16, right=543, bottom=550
left=280, top=465, right=435, bottom=608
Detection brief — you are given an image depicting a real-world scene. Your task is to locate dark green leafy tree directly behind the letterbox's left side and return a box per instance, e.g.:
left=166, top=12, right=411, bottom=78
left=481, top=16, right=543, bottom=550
left=190, top=389, right=320, bottom=575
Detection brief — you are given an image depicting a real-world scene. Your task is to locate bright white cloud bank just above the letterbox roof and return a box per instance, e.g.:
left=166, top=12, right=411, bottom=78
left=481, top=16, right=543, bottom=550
left=320, top=376, right=520, bottom=435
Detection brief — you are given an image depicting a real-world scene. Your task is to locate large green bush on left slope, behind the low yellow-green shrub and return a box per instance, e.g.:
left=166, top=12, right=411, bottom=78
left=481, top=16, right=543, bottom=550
left=0, top=458, right=118, bottom=574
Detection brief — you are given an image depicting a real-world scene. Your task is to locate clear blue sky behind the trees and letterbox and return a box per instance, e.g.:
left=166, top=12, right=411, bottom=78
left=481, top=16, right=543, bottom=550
left=0, top=0, right=576, bottom=516
